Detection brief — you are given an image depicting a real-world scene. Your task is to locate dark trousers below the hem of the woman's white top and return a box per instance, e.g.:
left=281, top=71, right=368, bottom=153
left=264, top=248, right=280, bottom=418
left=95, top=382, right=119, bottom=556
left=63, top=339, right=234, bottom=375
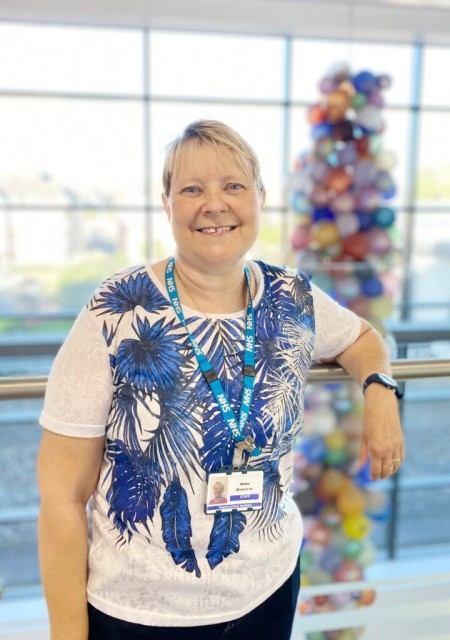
left=89, top=563, right=300, bottom=640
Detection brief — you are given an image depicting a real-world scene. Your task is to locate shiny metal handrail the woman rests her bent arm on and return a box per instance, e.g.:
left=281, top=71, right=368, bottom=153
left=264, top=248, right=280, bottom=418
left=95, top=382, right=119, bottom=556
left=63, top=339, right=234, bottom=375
left=0, top=359, right=450, bottom=400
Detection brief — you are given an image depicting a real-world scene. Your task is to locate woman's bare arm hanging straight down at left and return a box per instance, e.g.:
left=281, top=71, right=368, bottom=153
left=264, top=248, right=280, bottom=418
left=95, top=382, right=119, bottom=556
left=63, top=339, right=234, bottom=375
left=38, top=429, right=104, bottom=640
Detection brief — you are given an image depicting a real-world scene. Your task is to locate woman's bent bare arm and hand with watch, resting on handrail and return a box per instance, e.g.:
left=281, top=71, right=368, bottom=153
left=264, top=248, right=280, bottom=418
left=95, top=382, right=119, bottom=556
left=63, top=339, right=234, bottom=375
left=335, top=320, right=405, bottom=480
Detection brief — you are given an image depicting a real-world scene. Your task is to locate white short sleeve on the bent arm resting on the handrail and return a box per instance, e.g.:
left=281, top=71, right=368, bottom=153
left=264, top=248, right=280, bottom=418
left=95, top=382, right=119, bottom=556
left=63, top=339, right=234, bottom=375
left=311, top=284, right=361, bottom=362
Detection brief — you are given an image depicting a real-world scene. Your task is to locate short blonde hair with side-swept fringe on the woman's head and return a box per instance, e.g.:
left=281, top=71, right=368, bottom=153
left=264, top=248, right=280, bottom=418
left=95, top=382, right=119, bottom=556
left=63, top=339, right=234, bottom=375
left=163, top=120, right=264, bottom=196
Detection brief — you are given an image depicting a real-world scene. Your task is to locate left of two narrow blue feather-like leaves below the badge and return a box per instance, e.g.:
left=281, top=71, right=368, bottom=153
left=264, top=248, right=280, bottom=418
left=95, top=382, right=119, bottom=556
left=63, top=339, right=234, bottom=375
left=160, top=479, right=201, bottom=578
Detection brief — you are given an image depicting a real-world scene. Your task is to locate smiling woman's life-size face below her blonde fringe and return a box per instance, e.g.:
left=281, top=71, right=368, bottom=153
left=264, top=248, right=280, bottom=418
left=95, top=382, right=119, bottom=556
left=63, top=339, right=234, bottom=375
left=163, top=143, right=265, bottom=269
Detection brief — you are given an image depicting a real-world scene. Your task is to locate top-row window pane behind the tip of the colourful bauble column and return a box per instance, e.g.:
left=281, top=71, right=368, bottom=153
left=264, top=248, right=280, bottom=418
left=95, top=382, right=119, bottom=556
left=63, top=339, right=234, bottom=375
left=292, top=40, right=412, bottom=105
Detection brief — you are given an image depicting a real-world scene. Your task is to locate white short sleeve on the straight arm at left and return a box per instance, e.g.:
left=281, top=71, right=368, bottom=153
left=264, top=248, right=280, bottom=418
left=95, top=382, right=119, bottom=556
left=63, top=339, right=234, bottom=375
left=39, top=308, right=113, bottom=438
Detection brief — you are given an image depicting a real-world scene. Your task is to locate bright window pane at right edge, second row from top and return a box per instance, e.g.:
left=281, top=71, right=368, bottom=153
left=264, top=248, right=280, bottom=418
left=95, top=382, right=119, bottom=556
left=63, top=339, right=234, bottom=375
left=417, top=111, right=450, bottom=206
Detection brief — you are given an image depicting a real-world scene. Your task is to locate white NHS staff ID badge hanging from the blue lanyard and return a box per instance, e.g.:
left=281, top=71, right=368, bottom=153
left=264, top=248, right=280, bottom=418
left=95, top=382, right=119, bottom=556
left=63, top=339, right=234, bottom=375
left=205, top=468, right=264, bottom=514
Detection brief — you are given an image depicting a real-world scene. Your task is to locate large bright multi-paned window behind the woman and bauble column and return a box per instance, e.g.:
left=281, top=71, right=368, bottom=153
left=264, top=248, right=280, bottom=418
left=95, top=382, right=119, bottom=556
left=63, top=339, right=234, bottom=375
left=0, top=24, right=450, bottom=586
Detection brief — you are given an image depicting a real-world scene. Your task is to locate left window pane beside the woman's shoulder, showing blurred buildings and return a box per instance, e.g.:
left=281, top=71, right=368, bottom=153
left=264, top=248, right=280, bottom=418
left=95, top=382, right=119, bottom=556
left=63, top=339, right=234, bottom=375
left=0, top=210, right=146, bottom=318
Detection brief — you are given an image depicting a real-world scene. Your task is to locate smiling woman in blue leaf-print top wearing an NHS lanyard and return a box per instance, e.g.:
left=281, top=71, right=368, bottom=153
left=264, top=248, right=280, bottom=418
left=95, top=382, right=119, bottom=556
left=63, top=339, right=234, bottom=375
left=39, top=121, right=404, bottom=640
